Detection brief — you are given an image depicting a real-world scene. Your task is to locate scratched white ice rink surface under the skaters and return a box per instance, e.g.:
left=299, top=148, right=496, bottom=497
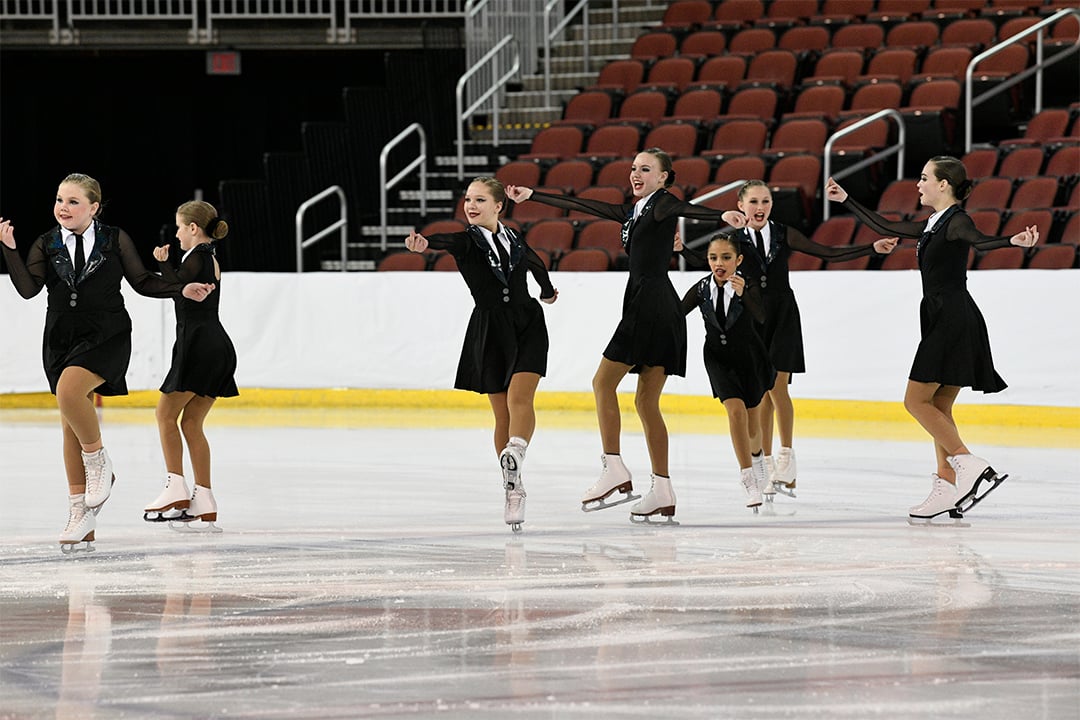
left=0, top=409, right=1080, bottom=720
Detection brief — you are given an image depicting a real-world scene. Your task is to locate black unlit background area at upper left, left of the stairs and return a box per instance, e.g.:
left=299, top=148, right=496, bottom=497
left=0, top=49, right=463, bottom=268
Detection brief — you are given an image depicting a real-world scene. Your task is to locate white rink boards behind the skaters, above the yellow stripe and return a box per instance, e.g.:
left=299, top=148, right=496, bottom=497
left=0, top=270, right=1080, bottom=407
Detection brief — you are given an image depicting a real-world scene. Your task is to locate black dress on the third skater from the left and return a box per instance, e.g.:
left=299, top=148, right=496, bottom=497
left=428, top=225, right=555, bottom=395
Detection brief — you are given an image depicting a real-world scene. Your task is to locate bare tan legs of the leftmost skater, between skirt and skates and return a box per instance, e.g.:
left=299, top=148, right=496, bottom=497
left=56, top=366, right=105, bottom=494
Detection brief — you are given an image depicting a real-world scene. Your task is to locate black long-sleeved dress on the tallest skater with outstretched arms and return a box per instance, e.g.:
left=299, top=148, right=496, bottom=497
left=530, top=189, right=723, bottom=376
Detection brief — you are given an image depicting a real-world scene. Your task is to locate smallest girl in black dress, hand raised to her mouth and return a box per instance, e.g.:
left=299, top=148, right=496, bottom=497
left=683, top=234, right=777, bottom=513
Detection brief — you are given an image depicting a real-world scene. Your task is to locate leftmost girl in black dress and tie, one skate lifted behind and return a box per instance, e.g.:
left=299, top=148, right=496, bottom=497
left=0, top=173, right=214, bottom=552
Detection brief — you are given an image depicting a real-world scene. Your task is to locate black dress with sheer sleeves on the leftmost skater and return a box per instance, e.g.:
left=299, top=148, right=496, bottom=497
left=0, top=220, right=184, bottom=395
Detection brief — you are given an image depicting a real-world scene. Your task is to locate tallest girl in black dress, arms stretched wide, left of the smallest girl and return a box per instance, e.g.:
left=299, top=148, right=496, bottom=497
left=507, top=148, right=734, bottom=519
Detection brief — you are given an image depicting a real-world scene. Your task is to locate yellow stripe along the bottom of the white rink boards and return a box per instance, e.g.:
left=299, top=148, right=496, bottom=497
left=6, top=388, right=1080, bottom=448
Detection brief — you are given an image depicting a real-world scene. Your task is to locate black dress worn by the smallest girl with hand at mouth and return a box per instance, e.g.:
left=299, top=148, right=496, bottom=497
left=683, top=275, right=777, bottom=408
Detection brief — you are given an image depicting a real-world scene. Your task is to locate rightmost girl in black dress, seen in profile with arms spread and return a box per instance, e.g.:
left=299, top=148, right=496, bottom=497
left=825, top=155, right=1039, bottom=520
